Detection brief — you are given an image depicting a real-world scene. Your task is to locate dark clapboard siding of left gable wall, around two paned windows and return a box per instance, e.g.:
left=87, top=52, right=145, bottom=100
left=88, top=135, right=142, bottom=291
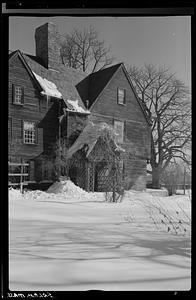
left=9, top=56, right=55, bottom=159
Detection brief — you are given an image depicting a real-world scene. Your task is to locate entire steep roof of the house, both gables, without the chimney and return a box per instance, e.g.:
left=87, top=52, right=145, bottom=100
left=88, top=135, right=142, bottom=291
left=9, top=50, right=151, bottom=125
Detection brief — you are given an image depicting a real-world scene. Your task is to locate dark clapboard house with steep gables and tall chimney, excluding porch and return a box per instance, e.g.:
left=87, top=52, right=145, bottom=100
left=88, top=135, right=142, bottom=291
left=8, top=23, right=150, bottom=190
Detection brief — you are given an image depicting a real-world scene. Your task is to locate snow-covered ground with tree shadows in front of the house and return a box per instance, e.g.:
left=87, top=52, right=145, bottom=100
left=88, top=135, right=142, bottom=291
left=9, top=181, right=191, bottom=291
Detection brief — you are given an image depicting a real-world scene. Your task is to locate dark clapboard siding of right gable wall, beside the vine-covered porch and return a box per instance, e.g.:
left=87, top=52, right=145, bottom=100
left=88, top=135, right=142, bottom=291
left=91, top=68, right=150, bottom=190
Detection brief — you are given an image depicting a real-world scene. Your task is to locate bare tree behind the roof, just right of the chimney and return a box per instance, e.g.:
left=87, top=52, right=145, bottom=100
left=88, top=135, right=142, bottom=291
left=61, top=27, right=114, bottom=73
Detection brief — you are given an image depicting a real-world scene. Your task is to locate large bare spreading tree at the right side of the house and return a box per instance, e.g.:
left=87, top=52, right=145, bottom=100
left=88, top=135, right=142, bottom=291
left=128, top=65, right=191, bottom=188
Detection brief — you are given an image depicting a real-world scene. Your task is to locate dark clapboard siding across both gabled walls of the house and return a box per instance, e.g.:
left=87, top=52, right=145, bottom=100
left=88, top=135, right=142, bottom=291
left=8, top=51, right=150, bottom=190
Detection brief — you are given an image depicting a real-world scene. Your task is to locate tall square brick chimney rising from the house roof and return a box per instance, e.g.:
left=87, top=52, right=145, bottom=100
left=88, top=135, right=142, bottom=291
left=35, top=22, right=61, bottom=70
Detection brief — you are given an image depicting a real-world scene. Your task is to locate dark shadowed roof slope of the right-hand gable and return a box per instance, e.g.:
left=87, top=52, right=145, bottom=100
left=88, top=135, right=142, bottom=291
left=76, top=63, right=122, bottom=107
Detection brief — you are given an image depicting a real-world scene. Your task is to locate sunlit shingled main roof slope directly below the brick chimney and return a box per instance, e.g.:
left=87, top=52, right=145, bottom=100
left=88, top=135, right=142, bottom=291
left=9, top=50, right=87, bottom=110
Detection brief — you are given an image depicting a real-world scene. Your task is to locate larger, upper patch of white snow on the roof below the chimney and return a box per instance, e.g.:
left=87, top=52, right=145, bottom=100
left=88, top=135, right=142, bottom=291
left=33, top=72, right=62, bottom=98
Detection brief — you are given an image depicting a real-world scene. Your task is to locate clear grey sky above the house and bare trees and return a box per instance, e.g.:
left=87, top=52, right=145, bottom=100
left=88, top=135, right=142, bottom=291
left=9, top=16, right=191, bottom=87
